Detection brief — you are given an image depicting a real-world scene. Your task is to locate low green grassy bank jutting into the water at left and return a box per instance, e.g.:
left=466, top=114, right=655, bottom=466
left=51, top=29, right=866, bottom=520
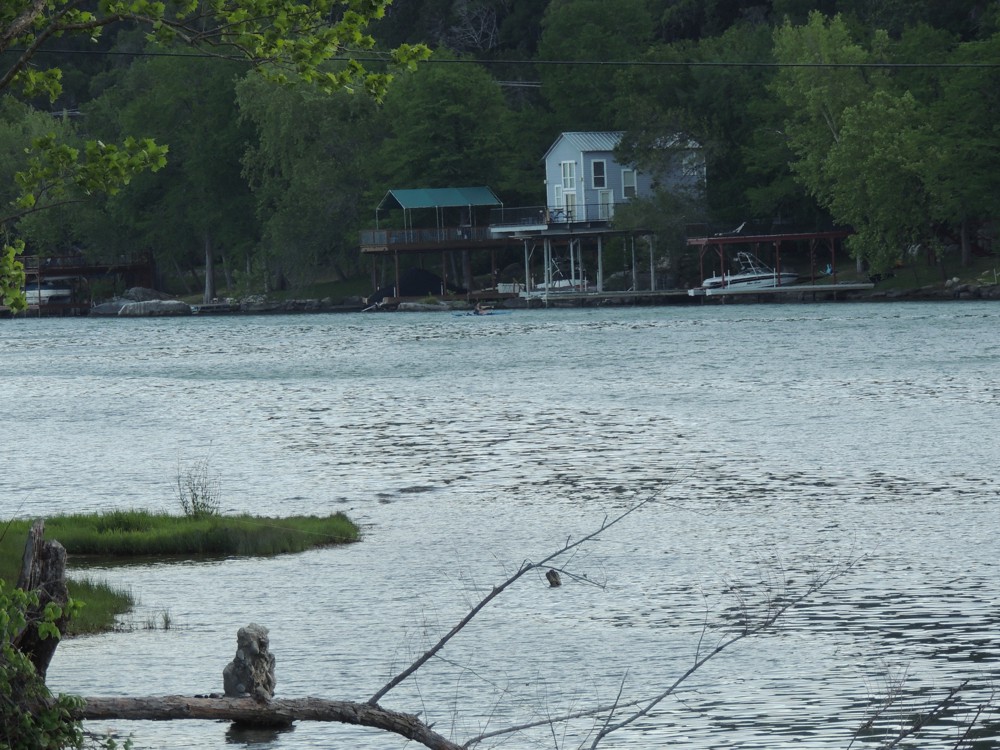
left=0, top=510, right=360, bottom=635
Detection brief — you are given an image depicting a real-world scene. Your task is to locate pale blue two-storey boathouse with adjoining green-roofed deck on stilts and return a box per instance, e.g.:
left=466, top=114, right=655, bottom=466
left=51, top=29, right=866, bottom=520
left=361, top=131, right=704, bottom=303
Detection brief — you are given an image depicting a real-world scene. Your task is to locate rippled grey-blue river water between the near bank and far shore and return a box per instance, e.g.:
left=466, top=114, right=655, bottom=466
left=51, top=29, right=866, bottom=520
left=0, top=302, right=1000, bottom=750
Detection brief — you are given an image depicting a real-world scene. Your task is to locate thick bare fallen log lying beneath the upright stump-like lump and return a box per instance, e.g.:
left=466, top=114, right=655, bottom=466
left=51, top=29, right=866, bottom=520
left=74, top=695, right=461, bottom=750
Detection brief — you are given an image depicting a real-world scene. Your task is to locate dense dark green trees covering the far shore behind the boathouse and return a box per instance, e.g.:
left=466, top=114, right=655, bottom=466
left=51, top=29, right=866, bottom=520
left=0, top=0, right=1000, bottom=302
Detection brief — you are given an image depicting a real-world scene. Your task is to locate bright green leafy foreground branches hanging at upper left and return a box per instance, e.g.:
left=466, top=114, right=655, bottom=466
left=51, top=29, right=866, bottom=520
left=0, top=0, right=426, bottom=307
